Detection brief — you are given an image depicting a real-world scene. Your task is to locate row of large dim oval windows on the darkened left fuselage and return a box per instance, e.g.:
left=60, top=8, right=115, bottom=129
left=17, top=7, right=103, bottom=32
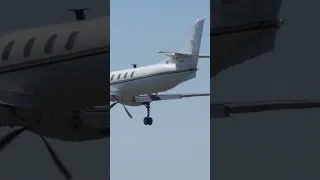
left=2, top=31, right=79, bottom=60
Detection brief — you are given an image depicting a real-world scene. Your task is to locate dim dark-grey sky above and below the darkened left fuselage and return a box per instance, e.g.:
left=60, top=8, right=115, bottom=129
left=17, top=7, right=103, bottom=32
left=0, top=0, right=109, bottom=180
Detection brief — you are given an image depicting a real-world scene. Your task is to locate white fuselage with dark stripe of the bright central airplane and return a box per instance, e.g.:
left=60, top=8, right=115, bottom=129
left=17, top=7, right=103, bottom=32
left=110, top=64, right=197, bottom=106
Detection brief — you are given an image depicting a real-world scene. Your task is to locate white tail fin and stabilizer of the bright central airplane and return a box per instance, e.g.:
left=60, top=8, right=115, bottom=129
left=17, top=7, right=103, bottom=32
left=159, top=19, right=210, bottom=69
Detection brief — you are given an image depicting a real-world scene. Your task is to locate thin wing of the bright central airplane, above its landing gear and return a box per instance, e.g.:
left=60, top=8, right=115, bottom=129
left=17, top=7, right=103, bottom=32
left=134, top=93, right=210, bottom=103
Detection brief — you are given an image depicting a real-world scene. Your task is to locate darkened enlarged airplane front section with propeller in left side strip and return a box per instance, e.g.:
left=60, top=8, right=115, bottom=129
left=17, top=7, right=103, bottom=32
left=0, top=8, right=110, bottom=179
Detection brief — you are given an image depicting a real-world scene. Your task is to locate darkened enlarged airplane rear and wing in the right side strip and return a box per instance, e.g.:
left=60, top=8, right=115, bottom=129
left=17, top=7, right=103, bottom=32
left=210, top=0, right=320, bottom=119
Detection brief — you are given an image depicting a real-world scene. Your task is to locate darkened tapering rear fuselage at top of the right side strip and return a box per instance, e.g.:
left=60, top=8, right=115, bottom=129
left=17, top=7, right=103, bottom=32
left=210, top=0, right=283, bottom=77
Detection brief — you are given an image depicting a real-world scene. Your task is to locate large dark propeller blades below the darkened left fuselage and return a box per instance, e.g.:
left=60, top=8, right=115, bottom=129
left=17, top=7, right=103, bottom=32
left=0, top=128, right=72, bottom=180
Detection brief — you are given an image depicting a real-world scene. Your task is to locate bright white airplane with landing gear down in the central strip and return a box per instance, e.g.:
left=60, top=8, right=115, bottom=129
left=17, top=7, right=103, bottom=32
left=110, top=19, right=210, bottom=125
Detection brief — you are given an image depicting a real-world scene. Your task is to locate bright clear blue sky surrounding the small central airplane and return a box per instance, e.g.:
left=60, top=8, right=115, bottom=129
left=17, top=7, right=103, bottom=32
left=110, top=0, right=210, bottom=180
